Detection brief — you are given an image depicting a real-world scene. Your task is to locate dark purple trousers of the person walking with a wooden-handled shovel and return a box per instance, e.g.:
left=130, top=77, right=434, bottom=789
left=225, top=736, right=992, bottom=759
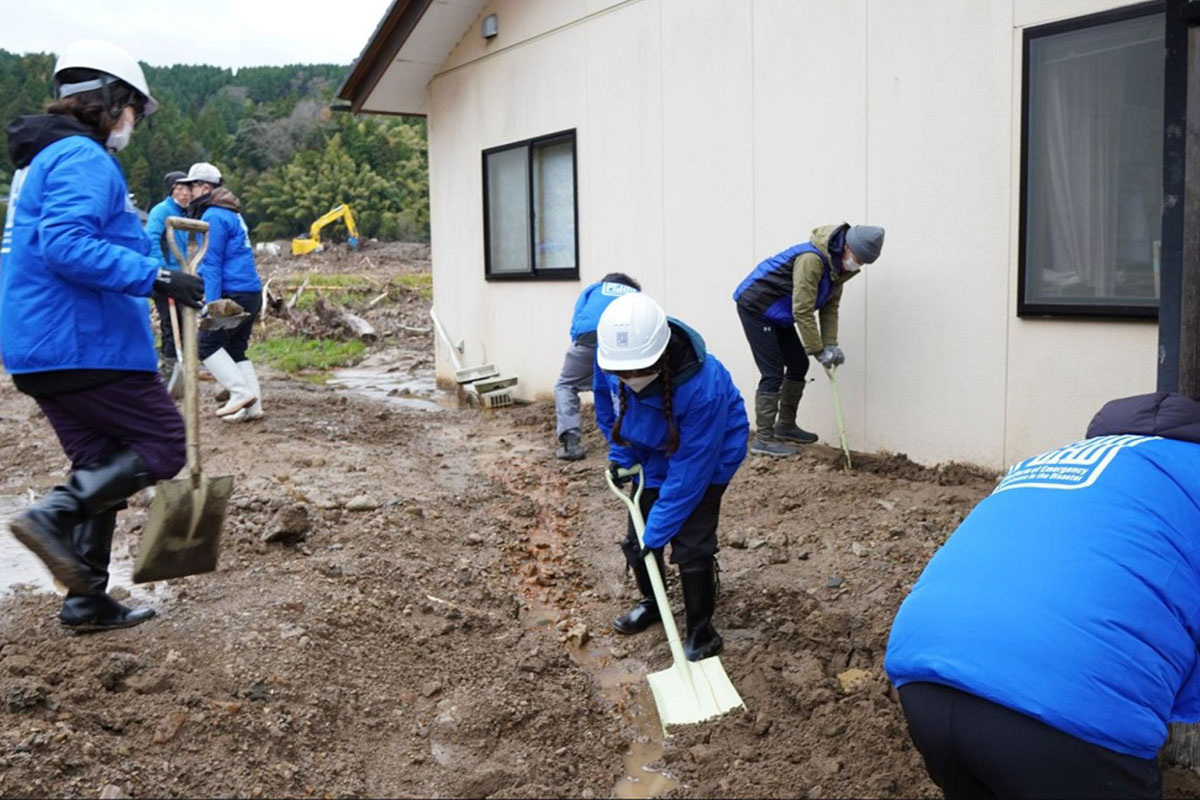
left=37, top=372, right=187, bottom=480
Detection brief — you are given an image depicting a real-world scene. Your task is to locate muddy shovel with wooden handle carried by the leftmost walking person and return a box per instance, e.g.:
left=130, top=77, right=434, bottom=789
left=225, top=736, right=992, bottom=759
left=133, top=217, right=233, bottom=583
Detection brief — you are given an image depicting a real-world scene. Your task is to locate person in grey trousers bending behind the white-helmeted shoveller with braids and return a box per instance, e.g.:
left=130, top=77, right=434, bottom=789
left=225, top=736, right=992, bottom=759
left=554, top=272, right=642, bottom=461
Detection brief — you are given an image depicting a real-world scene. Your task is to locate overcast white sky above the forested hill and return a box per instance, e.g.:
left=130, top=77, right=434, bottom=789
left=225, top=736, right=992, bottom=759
left=0, top=0, right=391, bottom=67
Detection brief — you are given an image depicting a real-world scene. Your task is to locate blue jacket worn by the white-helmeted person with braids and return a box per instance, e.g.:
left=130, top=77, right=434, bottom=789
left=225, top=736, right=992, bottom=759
left=593, top=319, right=750, bottom=547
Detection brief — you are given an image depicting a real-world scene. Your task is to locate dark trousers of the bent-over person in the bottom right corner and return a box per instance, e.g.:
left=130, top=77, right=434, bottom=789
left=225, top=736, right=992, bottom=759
left=900, top=682, right=1163, bottom=800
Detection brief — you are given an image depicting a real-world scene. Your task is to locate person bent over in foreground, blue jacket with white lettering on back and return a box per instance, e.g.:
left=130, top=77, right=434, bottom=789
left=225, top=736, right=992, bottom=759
left=884, top=392, right=1200, bottom=798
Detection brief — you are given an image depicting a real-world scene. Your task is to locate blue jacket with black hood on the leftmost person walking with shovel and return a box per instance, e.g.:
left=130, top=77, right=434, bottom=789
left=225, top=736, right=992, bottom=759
left=0, top=114, right=158, bottom=374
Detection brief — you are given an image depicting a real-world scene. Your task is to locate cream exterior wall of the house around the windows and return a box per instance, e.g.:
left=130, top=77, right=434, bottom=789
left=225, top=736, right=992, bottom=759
left=428, top=0, right=1157, bottom=468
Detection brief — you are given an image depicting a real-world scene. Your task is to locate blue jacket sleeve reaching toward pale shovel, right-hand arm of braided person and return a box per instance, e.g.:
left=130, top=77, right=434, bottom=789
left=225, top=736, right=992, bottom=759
left=642, top=388, right=728, bottom=549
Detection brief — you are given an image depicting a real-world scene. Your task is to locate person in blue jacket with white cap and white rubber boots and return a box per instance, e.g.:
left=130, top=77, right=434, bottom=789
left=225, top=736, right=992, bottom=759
left=182, top=162, right=263, bottom=422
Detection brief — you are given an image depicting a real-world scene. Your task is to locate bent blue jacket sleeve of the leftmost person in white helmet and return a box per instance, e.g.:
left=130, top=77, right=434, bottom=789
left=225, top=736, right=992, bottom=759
left=37, top=154, right=158, bottom=297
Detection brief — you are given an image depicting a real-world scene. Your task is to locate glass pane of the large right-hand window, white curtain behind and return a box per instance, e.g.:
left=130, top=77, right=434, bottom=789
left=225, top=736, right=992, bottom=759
left=1025, top=14, right=1163, bottom=303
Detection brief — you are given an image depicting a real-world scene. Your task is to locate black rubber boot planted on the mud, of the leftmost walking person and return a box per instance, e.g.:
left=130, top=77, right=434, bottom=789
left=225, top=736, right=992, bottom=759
left=59, top=504, right=155, bottom=633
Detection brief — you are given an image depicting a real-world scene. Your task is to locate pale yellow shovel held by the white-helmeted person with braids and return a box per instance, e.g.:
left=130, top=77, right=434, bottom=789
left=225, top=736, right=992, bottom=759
left=605, top=464, right=745, bottom=736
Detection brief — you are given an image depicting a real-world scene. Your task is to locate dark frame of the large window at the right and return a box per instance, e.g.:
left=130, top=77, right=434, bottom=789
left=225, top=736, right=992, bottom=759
left=1016, top=0, right=1166, bottom=321
